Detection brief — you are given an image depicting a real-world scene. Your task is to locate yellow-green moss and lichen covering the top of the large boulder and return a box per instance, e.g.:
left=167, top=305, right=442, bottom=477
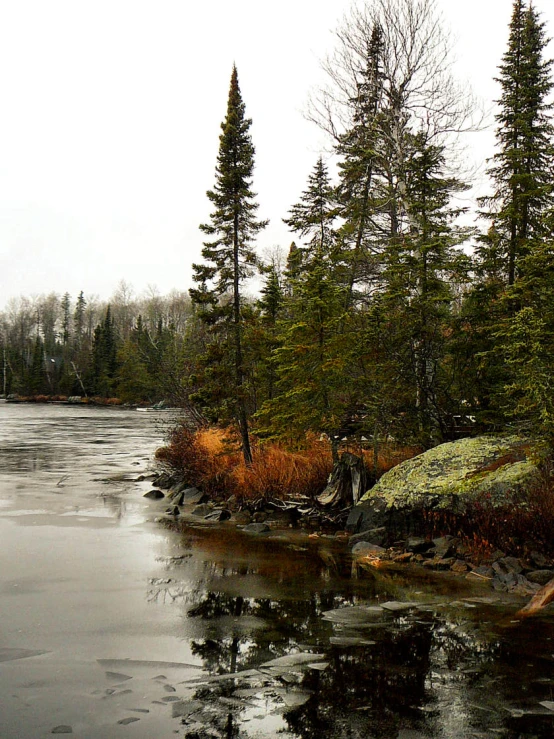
left=362, top=435, right=539, bottom=508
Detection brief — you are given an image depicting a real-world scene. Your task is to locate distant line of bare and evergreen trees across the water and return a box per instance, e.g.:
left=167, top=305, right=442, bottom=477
left=0, top=282, right=191, bottom=403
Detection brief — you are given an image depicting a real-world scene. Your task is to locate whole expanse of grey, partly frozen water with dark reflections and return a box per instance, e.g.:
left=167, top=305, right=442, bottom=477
left=0, top=403, right=554, bottom=739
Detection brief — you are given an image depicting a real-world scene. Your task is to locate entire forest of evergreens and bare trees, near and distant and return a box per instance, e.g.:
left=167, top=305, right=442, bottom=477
left=0, top=0, right=554, bottom=465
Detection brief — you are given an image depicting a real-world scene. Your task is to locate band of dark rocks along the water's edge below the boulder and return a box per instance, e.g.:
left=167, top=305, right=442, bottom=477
left=143, top=472, right=554, bottom=608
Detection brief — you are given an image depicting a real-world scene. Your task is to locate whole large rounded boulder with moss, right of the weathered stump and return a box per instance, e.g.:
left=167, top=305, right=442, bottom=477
left=347, top=435, right=540, bottom=531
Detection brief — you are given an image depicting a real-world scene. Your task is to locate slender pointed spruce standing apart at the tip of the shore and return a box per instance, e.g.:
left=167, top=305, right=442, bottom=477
left=190, top=66, right=267, bottom=464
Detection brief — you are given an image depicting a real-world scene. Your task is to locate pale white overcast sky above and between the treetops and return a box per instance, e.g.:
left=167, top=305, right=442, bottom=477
left=0, top=0, right=554, bottom=307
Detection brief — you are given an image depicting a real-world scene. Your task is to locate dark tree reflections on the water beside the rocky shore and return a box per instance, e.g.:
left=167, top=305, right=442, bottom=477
left=156, top=530, right=554, bottom=739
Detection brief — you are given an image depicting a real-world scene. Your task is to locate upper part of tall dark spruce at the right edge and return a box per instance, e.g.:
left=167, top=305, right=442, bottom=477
left=480, top=0, right=554, bottom=285
